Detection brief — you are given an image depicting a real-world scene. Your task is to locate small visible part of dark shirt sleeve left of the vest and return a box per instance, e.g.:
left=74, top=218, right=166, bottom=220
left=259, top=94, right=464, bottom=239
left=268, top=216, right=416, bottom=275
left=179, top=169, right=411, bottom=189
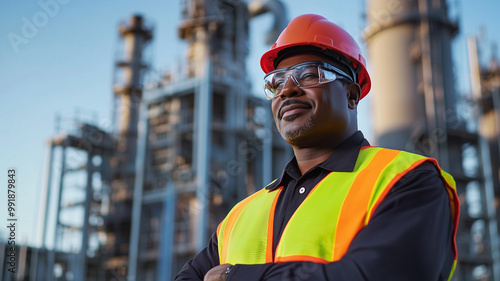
left=175, top=233, right=219, bottom=281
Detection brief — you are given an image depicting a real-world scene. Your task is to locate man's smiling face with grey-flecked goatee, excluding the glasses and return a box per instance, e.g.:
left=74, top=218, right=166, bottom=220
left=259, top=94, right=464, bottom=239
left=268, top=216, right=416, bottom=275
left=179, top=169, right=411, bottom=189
left=272, top=53, right=359, bottom=147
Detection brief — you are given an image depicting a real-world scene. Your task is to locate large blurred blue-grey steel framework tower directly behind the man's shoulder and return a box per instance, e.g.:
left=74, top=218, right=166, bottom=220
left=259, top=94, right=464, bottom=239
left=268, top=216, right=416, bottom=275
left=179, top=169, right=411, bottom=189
left=128, top=0, right=291, bottom=281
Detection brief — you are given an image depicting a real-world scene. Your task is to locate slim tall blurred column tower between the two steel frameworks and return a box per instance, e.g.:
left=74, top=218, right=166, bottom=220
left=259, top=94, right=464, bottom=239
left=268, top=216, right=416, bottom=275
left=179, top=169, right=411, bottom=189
left=100, top=15, right=153, bottom=276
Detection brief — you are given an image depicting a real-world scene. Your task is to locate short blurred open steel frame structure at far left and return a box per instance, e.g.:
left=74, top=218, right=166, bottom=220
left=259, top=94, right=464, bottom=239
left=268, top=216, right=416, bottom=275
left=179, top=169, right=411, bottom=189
left=41, top=117, right=113, bottom=280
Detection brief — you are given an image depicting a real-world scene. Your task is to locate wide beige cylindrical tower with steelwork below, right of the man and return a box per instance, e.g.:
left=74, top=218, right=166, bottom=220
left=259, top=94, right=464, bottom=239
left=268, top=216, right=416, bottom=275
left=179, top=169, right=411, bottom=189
left=364, top=0, right=500, bottom=281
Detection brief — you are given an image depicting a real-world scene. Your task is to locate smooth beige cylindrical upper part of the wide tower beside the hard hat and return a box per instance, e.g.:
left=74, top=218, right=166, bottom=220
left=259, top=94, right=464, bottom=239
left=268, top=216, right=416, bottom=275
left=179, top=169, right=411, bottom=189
left=364, top=0, right=456, bottom=153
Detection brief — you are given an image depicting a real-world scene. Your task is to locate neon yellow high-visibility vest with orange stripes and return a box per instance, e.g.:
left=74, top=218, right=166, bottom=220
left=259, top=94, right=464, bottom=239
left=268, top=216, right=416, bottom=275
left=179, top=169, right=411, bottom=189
left=217, top=147, right=459, bottom=278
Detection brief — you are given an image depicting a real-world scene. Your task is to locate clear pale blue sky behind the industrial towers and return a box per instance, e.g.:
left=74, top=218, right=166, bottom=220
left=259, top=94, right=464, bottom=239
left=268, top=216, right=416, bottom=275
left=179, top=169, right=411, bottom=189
left=0, top=0, right=500, bottom=244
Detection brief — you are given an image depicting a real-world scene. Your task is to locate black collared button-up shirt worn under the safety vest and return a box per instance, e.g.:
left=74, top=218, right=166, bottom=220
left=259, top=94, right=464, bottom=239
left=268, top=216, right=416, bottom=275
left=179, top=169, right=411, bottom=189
left=176, top=132, right=454, bottom=281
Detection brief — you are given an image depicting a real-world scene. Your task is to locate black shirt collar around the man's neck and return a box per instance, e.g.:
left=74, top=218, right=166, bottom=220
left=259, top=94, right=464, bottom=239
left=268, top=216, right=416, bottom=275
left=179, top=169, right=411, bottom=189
left=266, top=131, right=370, bottom=190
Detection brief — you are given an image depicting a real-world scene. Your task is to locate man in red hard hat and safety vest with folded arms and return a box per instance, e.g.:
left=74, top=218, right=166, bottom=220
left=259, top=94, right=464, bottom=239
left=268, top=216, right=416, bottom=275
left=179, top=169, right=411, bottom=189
left=176, top=15, right=458, bottom=281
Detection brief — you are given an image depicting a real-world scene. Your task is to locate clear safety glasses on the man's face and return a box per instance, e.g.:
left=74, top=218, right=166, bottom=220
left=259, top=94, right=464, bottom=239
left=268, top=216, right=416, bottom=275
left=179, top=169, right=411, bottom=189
left=264, top=61, right=353, bottom=100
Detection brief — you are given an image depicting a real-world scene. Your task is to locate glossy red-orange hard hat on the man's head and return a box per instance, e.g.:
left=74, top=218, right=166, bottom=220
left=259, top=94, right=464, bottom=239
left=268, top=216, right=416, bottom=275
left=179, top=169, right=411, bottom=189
left=260, top=14, right=371, bottom=99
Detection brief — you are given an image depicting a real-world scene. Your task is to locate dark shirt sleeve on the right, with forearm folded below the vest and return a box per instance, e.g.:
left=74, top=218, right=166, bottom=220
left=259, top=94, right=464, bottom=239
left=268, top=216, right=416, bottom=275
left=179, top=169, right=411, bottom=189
left=226, top=162, right=454, bottom=281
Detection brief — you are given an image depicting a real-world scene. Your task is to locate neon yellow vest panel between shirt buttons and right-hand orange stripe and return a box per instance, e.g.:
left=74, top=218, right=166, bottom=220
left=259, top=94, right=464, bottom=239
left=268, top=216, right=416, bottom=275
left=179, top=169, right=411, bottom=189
left=276, top=145, right=380, bottom=261
